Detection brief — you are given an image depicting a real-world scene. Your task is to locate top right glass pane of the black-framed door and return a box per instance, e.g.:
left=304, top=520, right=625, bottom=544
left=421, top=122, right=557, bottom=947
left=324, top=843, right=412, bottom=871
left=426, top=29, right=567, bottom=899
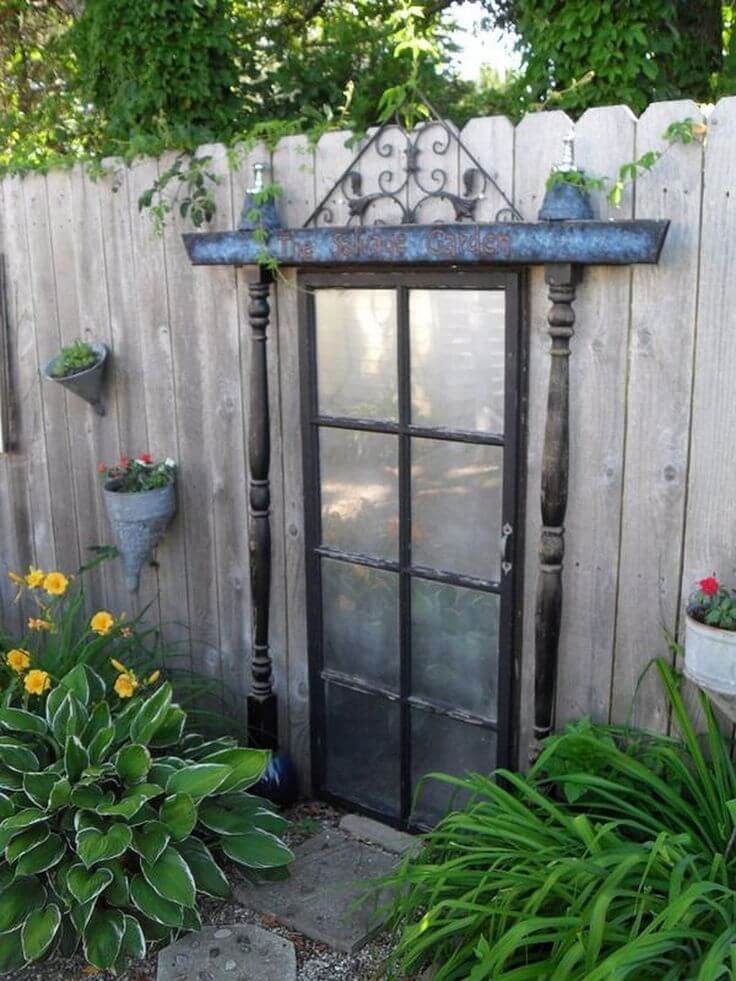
left=409, top=289, right=505, bottom=433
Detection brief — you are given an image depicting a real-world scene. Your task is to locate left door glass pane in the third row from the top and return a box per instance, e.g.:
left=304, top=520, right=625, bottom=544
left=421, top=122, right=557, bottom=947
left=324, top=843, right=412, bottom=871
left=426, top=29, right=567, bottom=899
left=322, top=559, right=399, bottom=691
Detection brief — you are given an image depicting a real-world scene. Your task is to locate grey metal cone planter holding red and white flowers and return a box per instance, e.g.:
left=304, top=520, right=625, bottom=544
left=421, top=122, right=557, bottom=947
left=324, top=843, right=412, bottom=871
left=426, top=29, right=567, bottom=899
left=104, top=480, right=176, bottom=593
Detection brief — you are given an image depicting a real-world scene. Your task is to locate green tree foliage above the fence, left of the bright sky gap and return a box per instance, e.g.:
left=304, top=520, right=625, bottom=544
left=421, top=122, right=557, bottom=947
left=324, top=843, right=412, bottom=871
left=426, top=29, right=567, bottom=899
left=0, top=0, right=470, bottom=170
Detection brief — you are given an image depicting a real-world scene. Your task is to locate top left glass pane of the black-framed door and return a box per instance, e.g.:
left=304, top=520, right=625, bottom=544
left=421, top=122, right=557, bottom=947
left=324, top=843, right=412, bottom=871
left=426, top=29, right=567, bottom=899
left=315, top=289, right=398, bottom=421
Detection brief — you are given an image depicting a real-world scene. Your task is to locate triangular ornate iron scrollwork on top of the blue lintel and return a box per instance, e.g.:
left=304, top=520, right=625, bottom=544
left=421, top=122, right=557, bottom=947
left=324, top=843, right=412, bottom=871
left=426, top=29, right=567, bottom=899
left=304, top=103, right=523, bottom=228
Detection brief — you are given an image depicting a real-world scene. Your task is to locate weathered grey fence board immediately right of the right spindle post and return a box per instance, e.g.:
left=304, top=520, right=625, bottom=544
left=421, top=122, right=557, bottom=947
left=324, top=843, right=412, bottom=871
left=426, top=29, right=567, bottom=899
left=557, top=106, right=636, bottom=724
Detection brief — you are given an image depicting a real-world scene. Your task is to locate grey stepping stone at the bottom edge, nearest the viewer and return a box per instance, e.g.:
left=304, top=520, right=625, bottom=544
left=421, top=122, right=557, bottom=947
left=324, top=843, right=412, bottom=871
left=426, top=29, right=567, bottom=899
left=156, top=923, right=296, bottom=981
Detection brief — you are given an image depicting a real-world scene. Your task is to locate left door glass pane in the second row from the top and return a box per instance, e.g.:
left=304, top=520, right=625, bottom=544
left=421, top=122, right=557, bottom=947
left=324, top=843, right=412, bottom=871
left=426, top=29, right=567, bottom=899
left=319, top=429, right=399, bottom=559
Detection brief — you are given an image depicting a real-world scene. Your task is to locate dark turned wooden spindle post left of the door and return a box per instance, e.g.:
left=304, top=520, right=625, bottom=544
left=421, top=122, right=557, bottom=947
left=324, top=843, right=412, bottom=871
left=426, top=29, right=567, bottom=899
left=248, top=269, right=278, bottom=750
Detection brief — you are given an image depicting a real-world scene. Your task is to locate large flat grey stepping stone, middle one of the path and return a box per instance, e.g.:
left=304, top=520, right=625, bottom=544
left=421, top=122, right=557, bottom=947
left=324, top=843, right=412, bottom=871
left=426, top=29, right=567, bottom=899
left=235, top=831, right=398, bottom=954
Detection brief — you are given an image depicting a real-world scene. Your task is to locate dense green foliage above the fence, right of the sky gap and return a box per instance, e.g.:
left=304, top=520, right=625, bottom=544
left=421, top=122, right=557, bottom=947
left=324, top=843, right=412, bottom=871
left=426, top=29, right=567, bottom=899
left=486, top=0, right=736, bottom=116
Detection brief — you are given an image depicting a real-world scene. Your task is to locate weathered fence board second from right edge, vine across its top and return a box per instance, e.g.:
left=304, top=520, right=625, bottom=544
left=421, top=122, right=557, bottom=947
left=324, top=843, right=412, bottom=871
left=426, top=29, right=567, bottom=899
left=611, top=100, right=703, bottom=729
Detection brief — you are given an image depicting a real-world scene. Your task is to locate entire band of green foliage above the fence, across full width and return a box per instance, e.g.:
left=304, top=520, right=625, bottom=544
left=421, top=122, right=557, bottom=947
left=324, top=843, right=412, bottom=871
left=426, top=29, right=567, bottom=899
left=0, top=0, right=736, bottom=182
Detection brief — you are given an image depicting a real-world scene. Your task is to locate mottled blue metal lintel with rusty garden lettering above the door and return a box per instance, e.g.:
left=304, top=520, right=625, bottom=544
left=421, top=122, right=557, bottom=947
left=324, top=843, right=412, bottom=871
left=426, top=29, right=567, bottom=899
left=183, top=219, right=669, bottom=267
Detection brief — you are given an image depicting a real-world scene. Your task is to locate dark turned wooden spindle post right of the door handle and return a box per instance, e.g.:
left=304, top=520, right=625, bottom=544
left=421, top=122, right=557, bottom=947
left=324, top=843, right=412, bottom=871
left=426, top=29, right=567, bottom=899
left=534, top=264, right=581, bottom=740
